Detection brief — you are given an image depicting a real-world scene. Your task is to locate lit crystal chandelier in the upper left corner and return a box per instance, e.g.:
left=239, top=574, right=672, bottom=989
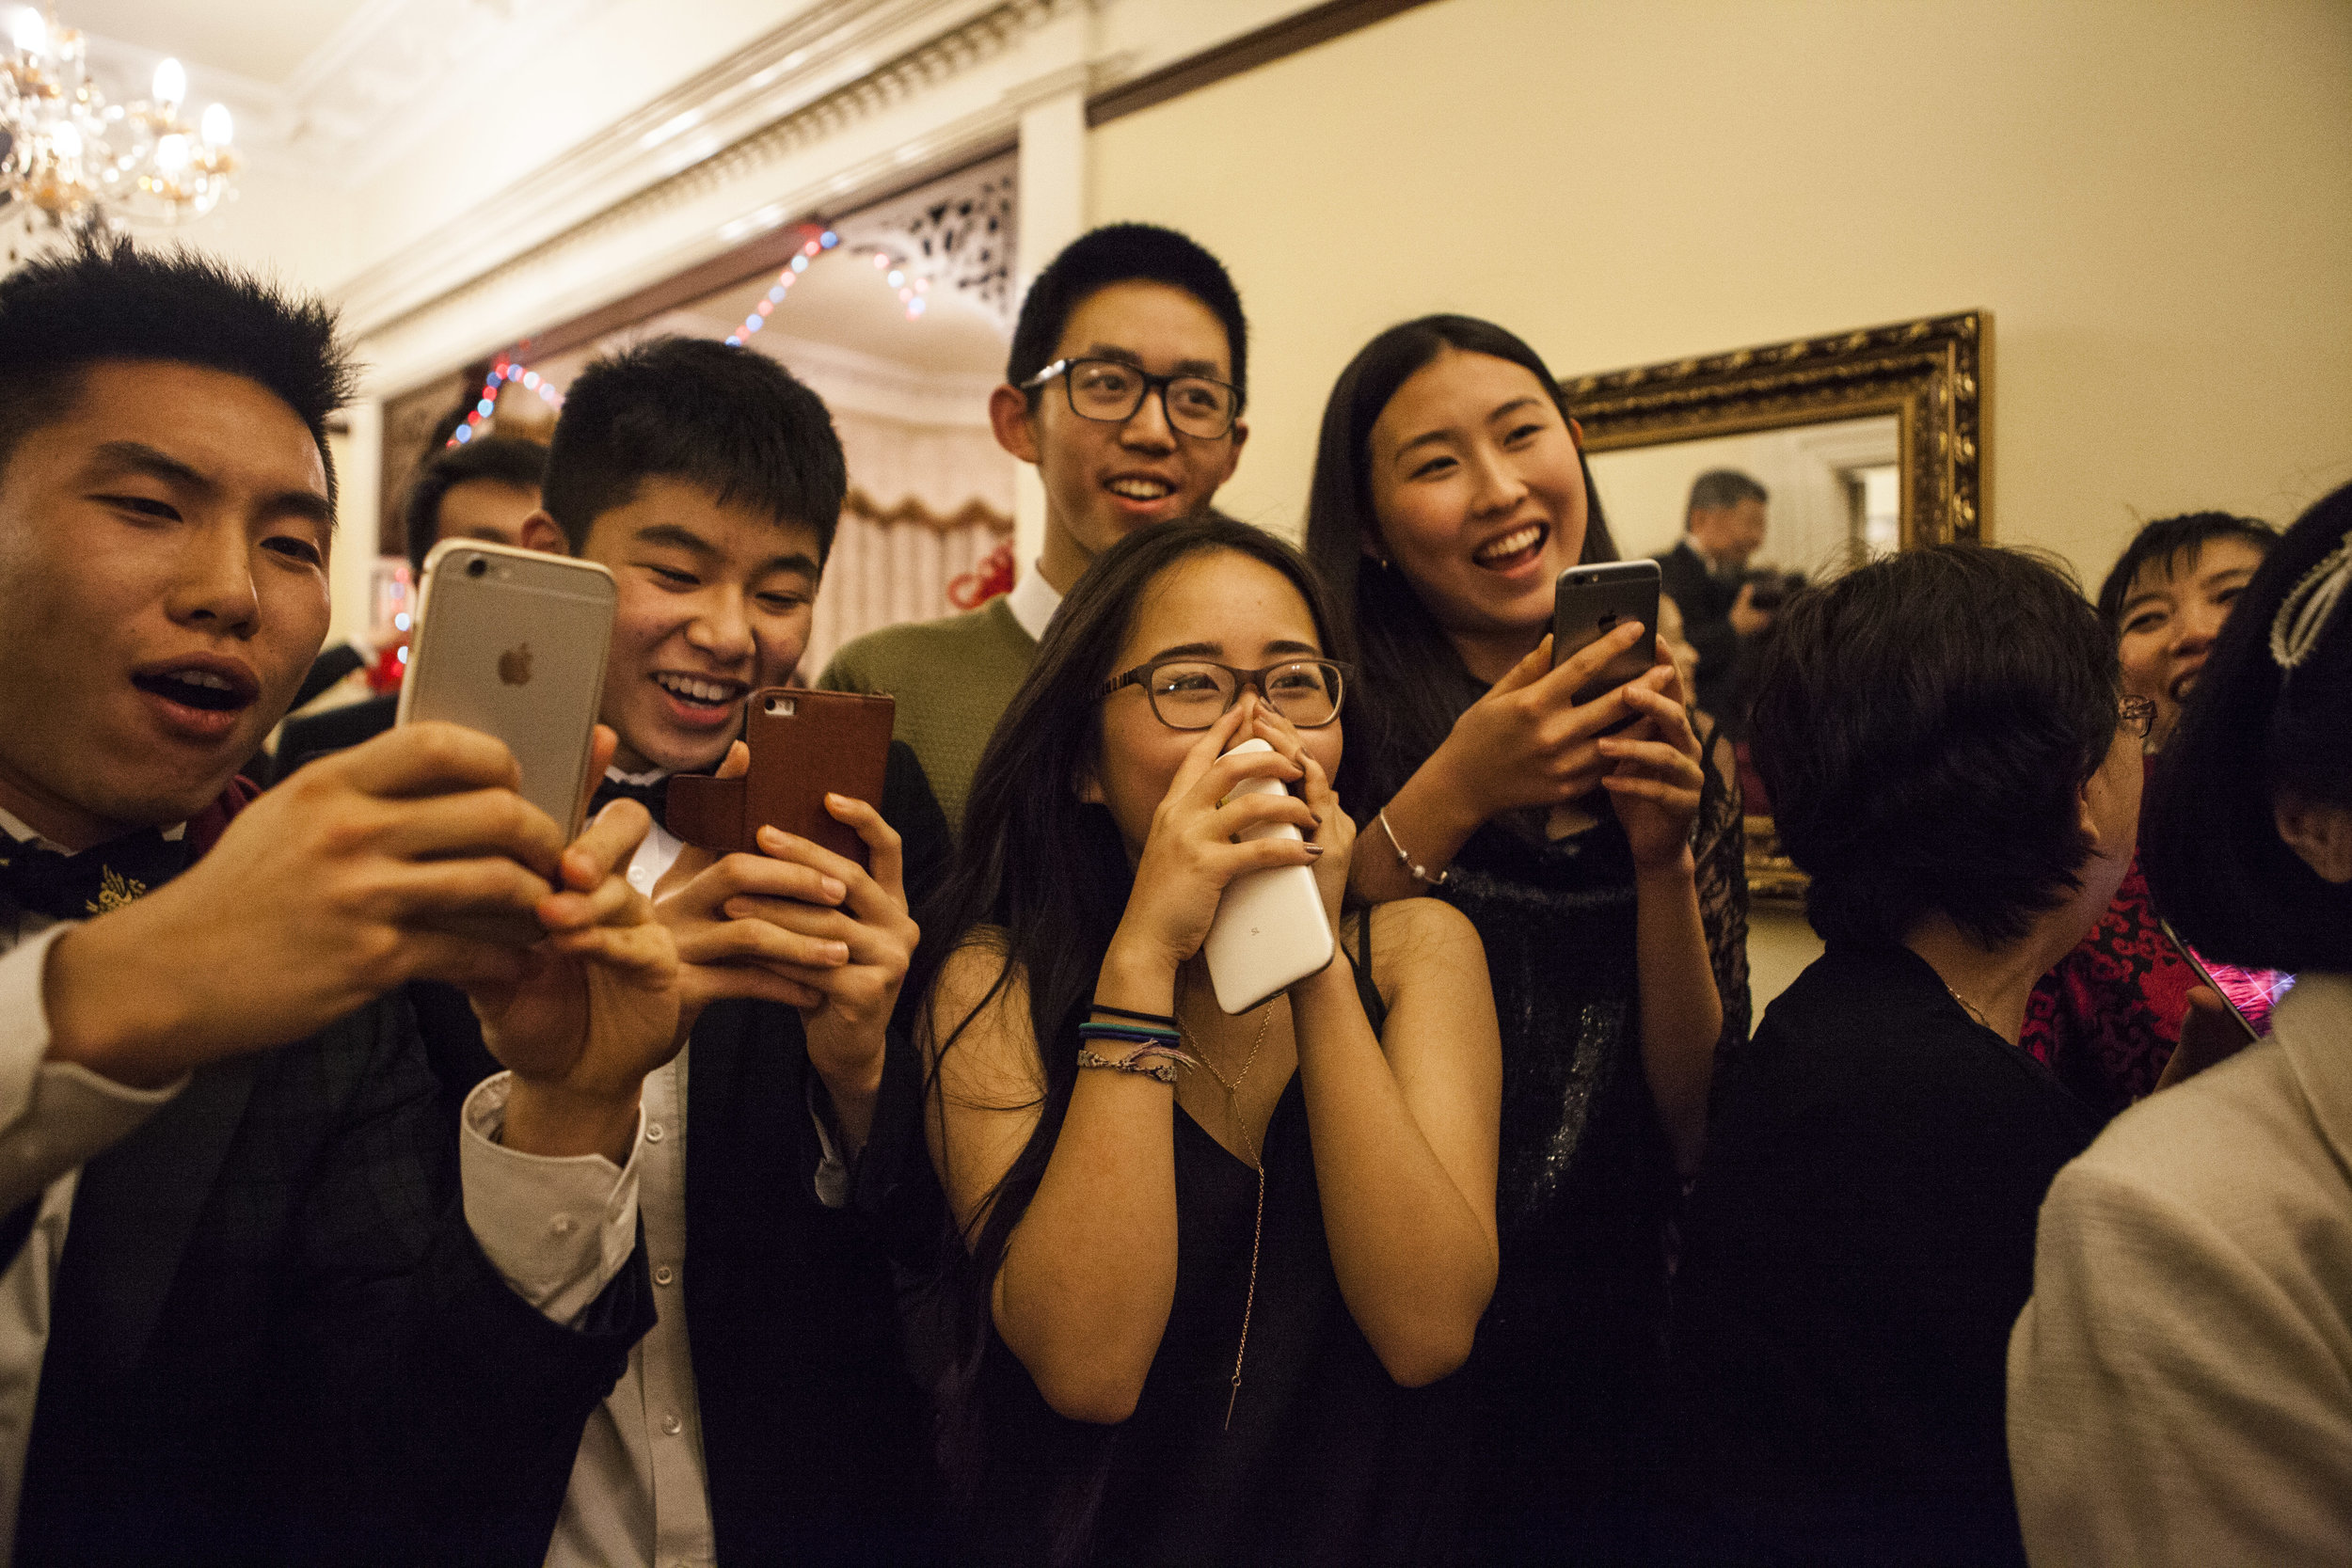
left=0, top=7, right=238, bottom=252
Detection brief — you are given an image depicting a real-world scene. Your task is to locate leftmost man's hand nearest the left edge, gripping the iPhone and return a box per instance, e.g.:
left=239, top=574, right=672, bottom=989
left=45, top=724, right=564, bottom=1086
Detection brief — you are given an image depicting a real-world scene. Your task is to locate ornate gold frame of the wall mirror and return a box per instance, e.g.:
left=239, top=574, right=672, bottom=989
left=1560, top=310, right=1993, bottom=905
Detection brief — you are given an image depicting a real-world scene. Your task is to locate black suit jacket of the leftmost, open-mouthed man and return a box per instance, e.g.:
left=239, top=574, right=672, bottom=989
left=17, top=994, right=654, bottom=1568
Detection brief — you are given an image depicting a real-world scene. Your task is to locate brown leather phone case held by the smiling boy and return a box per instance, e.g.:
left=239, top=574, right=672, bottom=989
left=666, top=687, right=898, bottom=865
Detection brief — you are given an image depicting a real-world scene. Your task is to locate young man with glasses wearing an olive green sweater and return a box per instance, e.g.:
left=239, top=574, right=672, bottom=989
left=817, top=223, right=1249, bottom=830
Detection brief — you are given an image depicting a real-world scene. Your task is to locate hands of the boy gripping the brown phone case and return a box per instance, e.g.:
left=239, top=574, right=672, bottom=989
left=654, top=740, right=922, bottom=1152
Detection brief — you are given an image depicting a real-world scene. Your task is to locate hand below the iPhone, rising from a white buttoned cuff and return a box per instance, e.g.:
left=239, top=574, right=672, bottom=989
left=466, top=724, right=677, bottom=1164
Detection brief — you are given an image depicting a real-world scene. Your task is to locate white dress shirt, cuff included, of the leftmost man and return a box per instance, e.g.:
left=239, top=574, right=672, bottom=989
left=0, top=811, right=638, bottom=1568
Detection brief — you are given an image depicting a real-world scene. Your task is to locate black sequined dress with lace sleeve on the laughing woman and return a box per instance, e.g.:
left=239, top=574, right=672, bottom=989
left=1439, top=720, right=1748, bottom=1563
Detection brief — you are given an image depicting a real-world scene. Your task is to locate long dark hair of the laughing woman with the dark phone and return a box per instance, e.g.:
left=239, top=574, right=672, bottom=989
left=1308, top=315, right=1618, bottom=816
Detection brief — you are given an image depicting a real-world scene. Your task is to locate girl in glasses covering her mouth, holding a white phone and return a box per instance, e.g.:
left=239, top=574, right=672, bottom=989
left=911, top=517, right=1499, bottom=1563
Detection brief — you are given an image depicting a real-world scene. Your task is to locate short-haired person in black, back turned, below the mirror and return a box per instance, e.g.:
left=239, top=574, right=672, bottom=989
left=1661, top=546, right=2148, bottom=1563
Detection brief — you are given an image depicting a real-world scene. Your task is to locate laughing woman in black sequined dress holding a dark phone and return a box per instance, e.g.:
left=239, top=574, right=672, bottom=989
left=1308, top=315, right=1748, bottom=1561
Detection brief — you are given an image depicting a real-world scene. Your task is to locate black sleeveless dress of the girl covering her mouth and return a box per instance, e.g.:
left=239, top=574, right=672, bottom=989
left=969, top=922, right=1458, bottom=1568
